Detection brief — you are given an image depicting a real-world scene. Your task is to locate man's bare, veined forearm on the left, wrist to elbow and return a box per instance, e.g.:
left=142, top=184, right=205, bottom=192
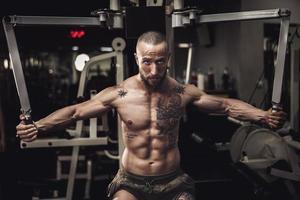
left=35, top=106, right=77, bottom=132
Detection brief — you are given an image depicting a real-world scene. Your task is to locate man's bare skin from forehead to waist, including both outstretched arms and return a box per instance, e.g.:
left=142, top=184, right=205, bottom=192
left=17, top=42, right=285, bottom=176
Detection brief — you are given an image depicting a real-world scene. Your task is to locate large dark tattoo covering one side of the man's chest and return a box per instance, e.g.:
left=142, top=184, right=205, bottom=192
left=156, top=87, right=184, bottom=147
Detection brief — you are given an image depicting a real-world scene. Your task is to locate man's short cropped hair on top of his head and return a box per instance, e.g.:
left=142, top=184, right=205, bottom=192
left=136, top=31, right=169, bottom=51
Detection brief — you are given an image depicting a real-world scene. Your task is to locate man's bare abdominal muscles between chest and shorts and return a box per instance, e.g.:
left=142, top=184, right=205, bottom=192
left=122, top=128, right=180, bottom=176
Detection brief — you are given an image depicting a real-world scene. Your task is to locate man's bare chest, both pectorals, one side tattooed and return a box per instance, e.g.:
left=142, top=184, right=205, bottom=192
left=117, top=90, right=184, bottom=130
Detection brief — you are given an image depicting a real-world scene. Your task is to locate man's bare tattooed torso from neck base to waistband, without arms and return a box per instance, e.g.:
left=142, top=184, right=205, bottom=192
left=113, top=76, right=190, bottom=175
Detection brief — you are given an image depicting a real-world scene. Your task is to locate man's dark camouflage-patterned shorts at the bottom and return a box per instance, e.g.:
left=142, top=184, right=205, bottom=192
left=107, top=169, right=195, bottom=200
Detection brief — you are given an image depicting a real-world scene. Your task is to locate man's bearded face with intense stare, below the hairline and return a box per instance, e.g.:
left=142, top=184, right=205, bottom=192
left=135, top=42, right=169, bottom=88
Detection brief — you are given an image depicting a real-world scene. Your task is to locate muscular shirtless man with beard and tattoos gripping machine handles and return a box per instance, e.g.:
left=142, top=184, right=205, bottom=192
left=16, top=32, right=285, bottom=200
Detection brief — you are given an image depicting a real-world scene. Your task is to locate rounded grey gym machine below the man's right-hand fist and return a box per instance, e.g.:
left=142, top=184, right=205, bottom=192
left=230, top=125, right=300, bottom=182
